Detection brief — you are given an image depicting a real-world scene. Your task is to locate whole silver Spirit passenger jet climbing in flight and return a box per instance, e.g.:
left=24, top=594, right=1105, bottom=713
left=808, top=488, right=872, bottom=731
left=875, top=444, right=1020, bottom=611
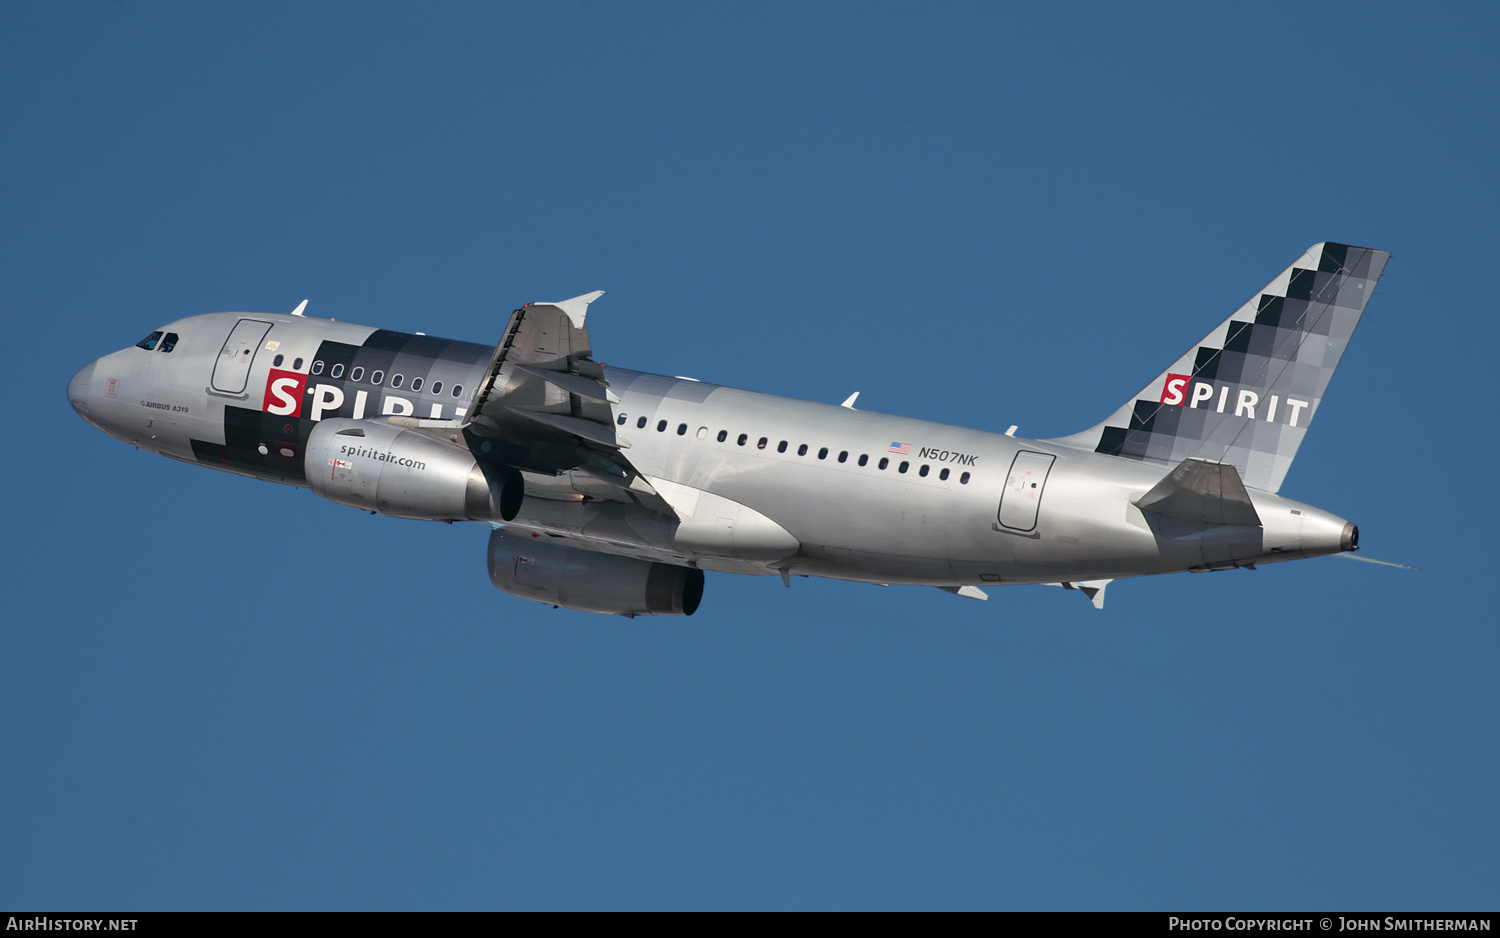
left=68, top=242, right=1400, bottom=617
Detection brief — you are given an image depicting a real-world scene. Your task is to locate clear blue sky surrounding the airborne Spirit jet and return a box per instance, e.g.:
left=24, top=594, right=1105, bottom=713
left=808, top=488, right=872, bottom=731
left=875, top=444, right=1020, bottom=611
left=0, top=2, right=1500, bottom=911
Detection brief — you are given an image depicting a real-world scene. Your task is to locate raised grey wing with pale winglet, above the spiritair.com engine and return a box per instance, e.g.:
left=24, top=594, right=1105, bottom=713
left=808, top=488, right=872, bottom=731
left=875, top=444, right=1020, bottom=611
left=464, top=290, right=672, bottom=516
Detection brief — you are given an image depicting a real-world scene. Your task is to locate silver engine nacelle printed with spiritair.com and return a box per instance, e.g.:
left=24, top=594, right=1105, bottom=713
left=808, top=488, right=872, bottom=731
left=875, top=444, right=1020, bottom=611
left=306, top=417, right=525, bottom=521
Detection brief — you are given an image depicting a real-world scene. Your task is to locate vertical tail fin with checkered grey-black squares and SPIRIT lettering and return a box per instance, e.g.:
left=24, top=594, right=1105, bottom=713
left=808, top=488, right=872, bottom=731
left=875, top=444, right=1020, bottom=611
left=1053, top=242, right=1391, bottom=492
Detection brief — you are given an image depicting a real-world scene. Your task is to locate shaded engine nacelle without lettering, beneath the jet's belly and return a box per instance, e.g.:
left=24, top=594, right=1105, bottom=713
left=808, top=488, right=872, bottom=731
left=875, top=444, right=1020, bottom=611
left=489, top=531, right=704, bottom=617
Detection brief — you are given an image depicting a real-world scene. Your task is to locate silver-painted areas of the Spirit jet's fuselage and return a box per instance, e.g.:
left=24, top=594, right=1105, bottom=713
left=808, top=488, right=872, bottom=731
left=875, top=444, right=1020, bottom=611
left=68, top=312, right=1346, bottom=585
